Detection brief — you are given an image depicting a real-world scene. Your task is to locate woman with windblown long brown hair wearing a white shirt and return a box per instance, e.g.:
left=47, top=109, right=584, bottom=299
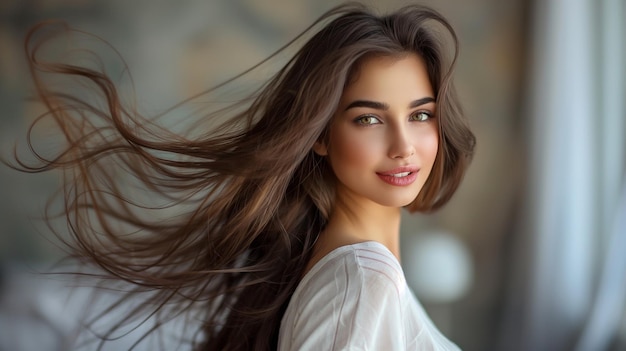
left=11, top=4, right=474, bottom=350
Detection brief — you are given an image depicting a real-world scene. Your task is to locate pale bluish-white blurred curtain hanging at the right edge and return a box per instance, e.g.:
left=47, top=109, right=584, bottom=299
left=499, top=0, right=626, bottom=351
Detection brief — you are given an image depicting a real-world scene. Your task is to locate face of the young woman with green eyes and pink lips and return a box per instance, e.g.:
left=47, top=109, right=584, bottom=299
left=315, top=54, right=439, bottom=207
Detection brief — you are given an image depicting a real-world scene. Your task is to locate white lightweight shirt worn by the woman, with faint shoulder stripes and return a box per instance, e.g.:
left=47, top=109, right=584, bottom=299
left=278, top=241, right=459, bottom=351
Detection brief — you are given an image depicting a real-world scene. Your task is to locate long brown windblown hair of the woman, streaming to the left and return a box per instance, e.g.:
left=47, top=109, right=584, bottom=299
left=6, top=4, right=475, bottom=350
